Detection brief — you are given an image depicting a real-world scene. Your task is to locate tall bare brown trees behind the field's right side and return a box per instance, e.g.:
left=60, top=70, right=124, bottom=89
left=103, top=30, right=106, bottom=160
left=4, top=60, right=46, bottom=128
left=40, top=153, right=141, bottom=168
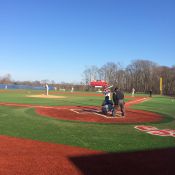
left=83, top=60, right=175, bottom=95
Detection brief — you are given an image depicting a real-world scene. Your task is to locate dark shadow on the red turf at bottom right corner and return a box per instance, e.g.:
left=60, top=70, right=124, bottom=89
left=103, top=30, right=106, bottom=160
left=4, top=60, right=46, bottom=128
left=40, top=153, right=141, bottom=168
left=70, top=148, right=175, bottom=175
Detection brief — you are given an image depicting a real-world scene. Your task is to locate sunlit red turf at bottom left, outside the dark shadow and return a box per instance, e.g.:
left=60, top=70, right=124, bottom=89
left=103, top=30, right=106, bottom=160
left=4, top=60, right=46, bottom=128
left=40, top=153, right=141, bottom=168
left=0, top=136, right=102, bottom=175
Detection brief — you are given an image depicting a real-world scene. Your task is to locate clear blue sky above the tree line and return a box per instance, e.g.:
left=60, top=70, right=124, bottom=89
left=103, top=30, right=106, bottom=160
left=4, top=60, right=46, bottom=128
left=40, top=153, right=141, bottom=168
left=0, top=0, right=175, bottom=82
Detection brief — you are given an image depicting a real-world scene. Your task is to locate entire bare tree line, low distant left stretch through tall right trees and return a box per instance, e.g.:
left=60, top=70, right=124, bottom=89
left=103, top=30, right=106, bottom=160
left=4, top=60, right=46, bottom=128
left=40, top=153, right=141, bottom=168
left=0, top=60, right=175, bottom=95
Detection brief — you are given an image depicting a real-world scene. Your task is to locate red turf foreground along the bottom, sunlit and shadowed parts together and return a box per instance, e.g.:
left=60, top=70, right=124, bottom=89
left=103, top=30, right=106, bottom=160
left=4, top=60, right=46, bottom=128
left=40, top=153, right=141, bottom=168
left=0, top=136, right=175, bottom=175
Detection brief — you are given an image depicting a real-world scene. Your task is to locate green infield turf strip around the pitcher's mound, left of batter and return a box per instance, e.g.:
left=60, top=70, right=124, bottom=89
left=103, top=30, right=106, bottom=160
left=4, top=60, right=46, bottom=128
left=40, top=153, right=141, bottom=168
left=0, top=90, right=104, bottom=106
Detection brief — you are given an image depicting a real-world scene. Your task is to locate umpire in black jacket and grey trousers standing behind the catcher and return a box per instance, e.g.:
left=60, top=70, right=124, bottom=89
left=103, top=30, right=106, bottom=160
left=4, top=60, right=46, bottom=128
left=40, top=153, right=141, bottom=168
left=112, top=87, right=125, bottom=117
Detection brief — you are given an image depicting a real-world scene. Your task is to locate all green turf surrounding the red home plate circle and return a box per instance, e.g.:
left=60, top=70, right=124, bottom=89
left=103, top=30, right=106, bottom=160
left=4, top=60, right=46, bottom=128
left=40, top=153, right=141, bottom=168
left=0, top=91, right=175, bottom=152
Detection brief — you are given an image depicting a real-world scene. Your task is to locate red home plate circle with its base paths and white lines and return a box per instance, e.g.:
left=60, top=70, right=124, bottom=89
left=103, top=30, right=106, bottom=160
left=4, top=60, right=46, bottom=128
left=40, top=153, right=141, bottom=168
left=0, top=95, right=163, bottom=123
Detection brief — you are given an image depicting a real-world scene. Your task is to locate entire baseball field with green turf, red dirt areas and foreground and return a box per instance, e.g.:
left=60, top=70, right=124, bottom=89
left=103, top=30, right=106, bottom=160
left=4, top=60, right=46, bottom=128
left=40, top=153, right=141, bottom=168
left=0, top=90, right=175, bottom=175
